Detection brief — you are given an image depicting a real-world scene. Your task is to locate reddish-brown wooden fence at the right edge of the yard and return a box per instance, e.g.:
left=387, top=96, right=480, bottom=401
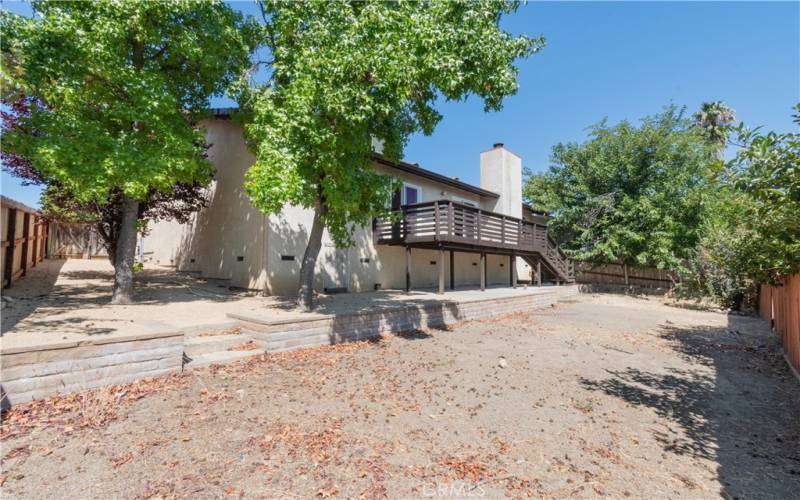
left=758, top=274, right=800, bottom=371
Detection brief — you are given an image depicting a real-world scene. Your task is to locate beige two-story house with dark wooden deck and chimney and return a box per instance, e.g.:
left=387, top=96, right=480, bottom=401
left=141, top=109, right=572, bottom=295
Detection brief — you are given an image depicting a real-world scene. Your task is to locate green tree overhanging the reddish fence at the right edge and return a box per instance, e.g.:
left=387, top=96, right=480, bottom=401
left=681, top=104, right=800, bottom=309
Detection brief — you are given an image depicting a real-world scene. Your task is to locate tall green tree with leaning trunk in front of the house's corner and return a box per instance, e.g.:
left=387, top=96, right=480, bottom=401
left=240, top=1, right=543, bottom=309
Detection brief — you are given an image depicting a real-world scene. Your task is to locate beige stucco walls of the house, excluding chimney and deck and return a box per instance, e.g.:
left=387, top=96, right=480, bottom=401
left=143, top=120, right=532, bottom=295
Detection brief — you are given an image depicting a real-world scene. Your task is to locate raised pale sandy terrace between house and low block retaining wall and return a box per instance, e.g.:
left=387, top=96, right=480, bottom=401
left=0, top=259, right=572, bottom=352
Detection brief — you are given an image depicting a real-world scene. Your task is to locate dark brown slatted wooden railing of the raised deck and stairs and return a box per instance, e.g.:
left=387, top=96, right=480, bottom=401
left=374, top=200, right=574, bottom=278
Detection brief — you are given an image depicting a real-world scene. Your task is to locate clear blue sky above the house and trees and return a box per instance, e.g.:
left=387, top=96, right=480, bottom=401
left=2, top=1, right=800, bottom=205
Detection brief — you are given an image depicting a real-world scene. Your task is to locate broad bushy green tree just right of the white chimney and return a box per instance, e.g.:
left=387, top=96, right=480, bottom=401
left=523, top=106, right=710, bottom=278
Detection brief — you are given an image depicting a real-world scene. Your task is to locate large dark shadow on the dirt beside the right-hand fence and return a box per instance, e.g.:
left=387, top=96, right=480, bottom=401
left=582, top=316, right=800, bottom=498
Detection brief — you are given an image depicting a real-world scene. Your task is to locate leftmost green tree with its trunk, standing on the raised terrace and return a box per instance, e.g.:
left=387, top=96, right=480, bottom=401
left=0, top=0, right=255, bottom=304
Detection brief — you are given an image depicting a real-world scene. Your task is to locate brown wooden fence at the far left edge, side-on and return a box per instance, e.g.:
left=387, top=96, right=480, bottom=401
left=0, top=196, right=47, bottom=288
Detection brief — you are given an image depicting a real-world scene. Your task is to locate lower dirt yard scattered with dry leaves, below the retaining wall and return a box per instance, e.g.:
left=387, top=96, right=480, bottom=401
left=2, top=296, right=800, bottom=498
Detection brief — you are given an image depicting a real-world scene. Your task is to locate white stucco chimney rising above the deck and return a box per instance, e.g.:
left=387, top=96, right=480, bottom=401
left=481, top=142, right=522, bottom=219
